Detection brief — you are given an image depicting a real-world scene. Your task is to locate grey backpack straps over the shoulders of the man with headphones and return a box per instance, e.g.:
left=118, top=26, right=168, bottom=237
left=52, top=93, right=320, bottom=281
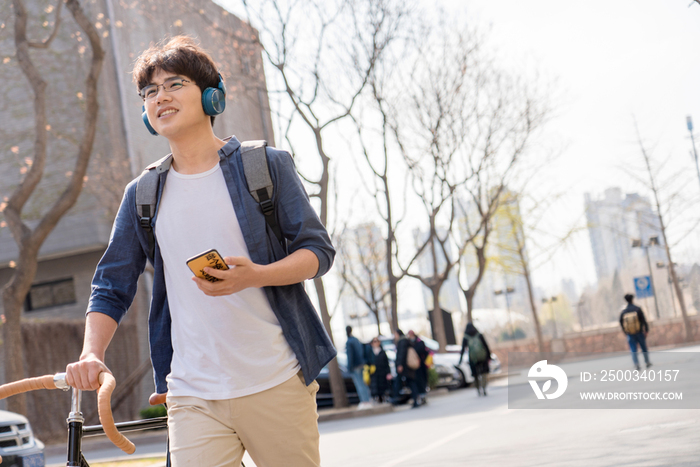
left=136, top=140, right=284, bottom=258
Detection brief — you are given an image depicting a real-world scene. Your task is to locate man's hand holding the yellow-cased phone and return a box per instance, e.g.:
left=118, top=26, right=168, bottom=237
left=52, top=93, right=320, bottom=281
left=192, top=256, right=264, bottom=297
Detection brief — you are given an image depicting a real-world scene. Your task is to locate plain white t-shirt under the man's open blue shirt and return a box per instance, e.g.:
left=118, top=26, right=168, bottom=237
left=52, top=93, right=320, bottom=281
left=155, top=164, right=299, bottom=400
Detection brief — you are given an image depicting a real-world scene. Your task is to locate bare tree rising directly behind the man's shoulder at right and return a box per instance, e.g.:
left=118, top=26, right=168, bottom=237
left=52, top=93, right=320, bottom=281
left=242, top=0, right=408, bottom=407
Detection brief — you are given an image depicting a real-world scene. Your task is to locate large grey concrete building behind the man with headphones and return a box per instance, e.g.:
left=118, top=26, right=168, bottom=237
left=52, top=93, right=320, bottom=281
left=0, top=0, right=274, bottom=402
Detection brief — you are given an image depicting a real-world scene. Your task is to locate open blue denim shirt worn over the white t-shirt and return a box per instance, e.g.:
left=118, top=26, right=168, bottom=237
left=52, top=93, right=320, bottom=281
left=87, top=136, right=336, bottom=393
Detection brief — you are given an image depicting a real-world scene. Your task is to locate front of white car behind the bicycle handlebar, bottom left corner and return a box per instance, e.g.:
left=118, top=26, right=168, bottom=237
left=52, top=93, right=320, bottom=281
left=0, top=410, right=45, bottom=467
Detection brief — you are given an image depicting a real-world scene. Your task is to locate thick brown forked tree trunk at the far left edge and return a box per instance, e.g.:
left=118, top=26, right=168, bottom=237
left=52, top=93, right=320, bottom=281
left=2, top=0, right=104, bottom=413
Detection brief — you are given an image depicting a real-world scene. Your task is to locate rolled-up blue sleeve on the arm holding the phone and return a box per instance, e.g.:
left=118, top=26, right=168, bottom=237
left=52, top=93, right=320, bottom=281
left=268, top=148, right=335, bottom=278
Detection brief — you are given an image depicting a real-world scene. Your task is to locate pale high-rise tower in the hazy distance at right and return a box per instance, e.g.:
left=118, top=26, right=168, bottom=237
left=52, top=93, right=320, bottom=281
left=585, top=187, right=662, bottom=280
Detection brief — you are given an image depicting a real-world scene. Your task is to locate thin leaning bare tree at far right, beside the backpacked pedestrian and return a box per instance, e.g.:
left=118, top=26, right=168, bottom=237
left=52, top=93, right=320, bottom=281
left=635, top=124, right=700, bottom=342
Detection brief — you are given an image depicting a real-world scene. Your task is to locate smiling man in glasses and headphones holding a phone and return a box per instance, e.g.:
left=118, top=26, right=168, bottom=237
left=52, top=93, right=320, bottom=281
left=66, top=36, right=335, bottom=467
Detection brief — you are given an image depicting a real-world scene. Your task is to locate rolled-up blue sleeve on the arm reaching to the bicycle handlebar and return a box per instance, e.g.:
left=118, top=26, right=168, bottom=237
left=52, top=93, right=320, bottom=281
left=87, top=182, right=146, bottom=323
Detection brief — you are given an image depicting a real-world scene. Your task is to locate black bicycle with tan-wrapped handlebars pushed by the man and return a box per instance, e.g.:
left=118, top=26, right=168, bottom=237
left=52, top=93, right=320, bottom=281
left=0, top=372, right=170, bottom=467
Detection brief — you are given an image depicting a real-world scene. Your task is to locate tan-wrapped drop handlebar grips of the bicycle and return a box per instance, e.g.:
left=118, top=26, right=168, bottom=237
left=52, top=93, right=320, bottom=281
left=0, top=372, right=136, bottom=459
